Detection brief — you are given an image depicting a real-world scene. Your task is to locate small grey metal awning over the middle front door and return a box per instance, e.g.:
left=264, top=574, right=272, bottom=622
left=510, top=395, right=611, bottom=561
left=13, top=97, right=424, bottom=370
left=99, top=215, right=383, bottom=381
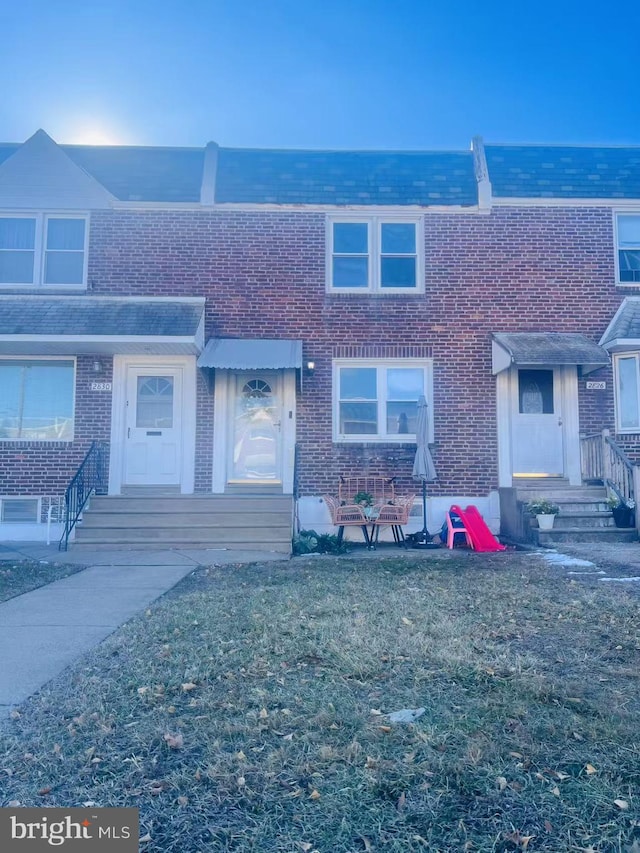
left=198, top=338, right=302, bottom=370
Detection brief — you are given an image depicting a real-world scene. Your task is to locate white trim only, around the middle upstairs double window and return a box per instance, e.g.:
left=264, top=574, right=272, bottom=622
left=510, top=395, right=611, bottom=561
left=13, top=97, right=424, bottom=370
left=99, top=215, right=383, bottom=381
left=325, top=214, right=424, bottom=296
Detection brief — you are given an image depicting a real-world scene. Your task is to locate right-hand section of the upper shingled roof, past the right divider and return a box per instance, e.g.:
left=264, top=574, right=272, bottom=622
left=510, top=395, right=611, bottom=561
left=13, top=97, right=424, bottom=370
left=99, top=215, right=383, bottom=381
left=485, top=145, right=640, bottom=199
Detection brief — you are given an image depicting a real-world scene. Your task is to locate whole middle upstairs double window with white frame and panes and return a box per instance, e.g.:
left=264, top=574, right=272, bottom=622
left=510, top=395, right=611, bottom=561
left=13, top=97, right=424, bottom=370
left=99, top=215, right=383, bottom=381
left=327, top=216, right=424, bottom=294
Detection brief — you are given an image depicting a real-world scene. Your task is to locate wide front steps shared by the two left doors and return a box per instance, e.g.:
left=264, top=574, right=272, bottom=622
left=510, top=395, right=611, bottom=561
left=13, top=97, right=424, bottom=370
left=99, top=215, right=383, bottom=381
left=74, top=493, right=293, bottom=554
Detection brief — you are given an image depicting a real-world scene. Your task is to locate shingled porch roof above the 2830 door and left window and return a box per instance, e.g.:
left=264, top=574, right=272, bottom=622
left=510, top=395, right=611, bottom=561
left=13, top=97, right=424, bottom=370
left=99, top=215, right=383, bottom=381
left=0, top=296, right=204, bottom=337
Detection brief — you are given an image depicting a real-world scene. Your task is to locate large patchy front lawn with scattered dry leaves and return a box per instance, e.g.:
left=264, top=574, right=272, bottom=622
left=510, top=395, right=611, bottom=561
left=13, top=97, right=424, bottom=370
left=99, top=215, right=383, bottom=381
left=0, top=551, right=640, bottom=853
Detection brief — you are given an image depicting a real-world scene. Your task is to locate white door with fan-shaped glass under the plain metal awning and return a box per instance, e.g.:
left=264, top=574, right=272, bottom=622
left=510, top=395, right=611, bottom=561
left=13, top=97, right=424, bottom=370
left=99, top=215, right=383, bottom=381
left=227, top=371, right=282, bottom=484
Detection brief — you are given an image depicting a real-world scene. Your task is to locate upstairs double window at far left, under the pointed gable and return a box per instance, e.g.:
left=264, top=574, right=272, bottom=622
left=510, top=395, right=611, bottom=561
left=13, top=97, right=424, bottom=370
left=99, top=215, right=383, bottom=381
left=0, top=213, right=89, bottom=288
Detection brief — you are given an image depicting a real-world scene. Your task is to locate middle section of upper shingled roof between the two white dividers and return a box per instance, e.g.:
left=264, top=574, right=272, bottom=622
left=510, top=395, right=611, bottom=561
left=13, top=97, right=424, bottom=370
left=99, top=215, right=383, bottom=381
left=216, top=148, right=478, bottom=205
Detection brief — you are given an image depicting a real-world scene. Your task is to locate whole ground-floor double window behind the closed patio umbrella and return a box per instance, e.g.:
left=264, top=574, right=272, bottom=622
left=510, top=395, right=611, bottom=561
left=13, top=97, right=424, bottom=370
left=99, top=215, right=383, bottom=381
left=333, top=359, right=433, bottom=442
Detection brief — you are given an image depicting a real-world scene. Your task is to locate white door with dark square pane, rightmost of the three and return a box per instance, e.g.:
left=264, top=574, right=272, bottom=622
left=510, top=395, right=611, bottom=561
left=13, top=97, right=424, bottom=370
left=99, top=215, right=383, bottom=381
left=510, top=367, right=565, bottom=477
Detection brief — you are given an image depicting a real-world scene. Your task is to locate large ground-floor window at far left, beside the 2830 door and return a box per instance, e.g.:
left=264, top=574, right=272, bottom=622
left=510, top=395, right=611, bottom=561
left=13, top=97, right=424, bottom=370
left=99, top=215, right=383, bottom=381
left=0, top=358, right=76, bottom=441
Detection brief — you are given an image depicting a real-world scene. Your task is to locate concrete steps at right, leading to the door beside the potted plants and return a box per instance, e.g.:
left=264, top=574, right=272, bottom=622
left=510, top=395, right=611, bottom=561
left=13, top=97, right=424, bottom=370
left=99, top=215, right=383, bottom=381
left=516, top=480, right=638, bottom=547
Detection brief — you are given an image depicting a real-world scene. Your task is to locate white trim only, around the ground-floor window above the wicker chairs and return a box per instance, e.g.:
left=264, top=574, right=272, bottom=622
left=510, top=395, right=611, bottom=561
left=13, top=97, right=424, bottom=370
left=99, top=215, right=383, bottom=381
left=331, top=358, right=434, bottom=444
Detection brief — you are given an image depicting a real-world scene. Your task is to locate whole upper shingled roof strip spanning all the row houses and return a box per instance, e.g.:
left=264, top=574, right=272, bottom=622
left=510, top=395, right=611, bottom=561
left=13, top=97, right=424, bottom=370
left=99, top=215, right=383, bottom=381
left=0, top=136, right=640, bottom=206
